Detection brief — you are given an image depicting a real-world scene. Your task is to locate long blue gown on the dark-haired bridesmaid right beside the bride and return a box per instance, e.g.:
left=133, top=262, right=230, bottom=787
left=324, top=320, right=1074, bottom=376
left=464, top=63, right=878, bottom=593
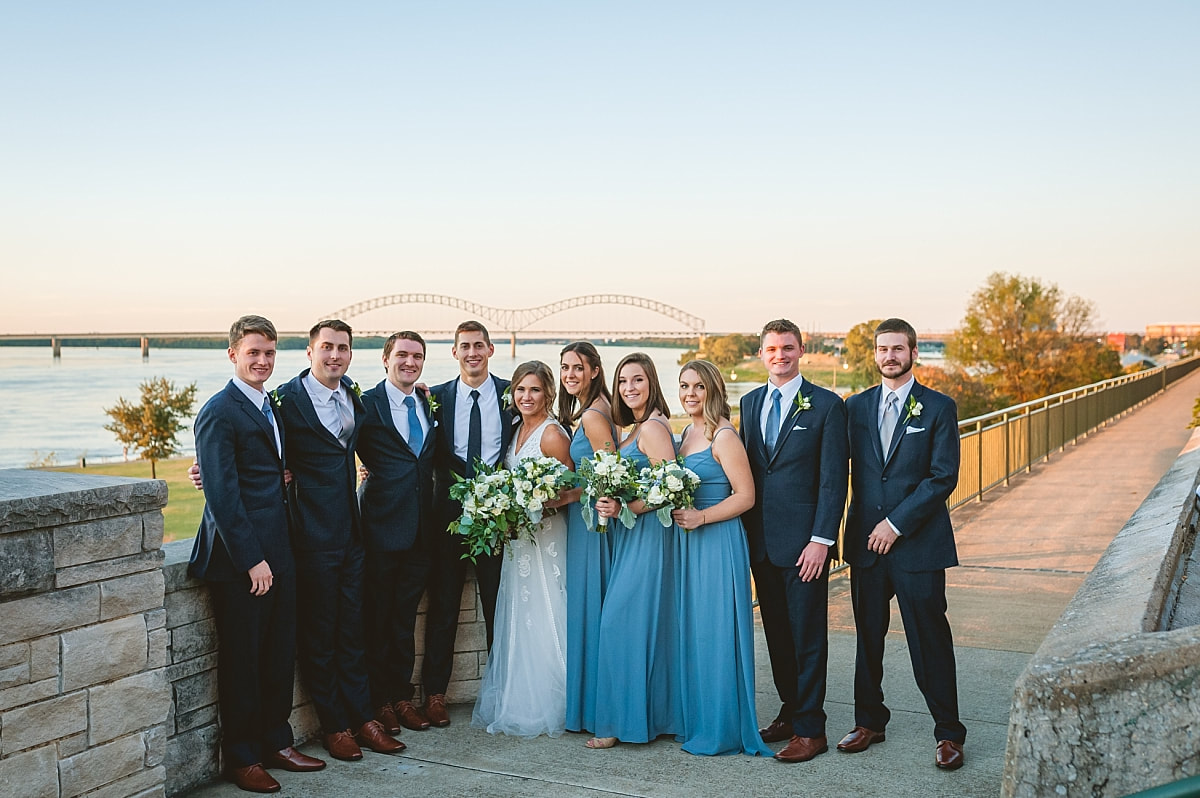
left=564, top=409, right=619, bottom=732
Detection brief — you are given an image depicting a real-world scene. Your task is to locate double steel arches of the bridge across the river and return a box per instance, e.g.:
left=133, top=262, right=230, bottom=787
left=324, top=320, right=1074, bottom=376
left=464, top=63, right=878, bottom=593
left=322, top=294, right=704, bottom=335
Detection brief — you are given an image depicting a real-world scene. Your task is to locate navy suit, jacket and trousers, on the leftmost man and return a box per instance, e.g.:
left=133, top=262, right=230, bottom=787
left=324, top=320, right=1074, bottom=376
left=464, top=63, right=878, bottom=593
left=187, top=380, right=296, bottom=768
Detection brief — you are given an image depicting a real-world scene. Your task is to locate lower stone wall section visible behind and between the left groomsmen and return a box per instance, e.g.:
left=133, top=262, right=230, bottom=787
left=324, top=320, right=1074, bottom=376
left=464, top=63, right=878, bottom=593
left=163, top=540, right=487, bottom=796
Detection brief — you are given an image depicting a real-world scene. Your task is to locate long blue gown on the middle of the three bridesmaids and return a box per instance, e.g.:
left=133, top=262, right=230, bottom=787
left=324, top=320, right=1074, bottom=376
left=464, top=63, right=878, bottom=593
left=594, top=417, right=683, bottom=743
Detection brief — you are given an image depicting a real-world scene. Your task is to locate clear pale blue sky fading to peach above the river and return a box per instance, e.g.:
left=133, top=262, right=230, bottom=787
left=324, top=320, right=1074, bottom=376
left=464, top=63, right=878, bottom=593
left=0, top=0, right=1200, bottom=332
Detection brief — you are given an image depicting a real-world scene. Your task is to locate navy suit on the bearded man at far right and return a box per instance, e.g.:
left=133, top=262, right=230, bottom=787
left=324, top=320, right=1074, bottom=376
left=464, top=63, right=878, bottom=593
left=845, top=383, right=966, bottom=743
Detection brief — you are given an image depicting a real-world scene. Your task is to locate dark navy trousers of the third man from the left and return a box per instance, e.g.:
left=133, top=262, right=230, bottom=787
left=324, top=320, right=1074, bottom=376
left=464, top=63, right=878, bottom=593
left=366, top=540, right=431, bottom=707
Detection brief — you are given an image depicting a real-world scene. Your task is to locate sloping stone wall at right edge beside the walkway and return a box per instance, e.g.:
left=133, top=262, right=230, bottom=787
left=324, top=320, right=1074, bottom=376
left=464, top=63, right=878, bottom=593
left=1002, top=431, right=1200, bottom=798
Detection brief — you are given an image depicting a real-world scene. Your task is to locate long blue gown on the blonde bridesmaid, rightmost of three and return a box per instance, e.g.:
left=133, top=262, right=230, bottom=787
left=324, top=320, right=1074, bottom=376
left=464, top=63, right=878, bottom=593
left=678, top=422, right=772, bottom=756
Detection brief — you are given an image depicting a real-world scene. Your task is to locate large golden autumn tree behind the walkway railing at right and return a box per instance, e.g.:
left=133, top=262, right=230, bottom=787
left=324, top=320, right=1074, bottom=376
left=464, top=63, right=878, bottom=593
left=946, top=271, right=1121, bottom=408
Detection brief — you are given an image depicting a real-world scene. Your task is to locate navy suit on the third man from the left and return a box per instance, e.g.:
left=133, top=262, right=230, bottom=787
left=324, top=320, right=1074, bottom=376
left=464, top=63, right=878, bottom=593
left=356, top=380, right=444, bottom=707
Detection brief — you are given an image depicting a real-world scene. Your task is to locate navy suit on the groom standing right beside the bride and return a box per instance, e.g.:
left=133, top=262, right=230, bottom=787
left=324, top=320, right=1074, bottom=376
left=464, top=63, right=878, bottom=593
left=421, top=376, right=512, bottom=695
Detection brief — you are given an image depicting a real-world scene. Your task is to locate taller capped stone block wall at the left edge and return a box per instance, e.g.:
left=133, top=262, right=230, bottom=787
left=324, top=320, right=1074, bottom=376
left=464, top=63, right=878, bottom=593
left=0, top=470, right=170, bottom=798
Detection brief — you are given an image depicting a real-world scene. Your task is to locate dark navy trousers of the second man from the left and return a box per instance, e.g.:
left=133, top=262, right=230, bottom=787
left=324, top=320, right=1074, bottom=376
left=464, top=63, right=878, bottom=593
left=295, top=542, right=372, bottom=734
